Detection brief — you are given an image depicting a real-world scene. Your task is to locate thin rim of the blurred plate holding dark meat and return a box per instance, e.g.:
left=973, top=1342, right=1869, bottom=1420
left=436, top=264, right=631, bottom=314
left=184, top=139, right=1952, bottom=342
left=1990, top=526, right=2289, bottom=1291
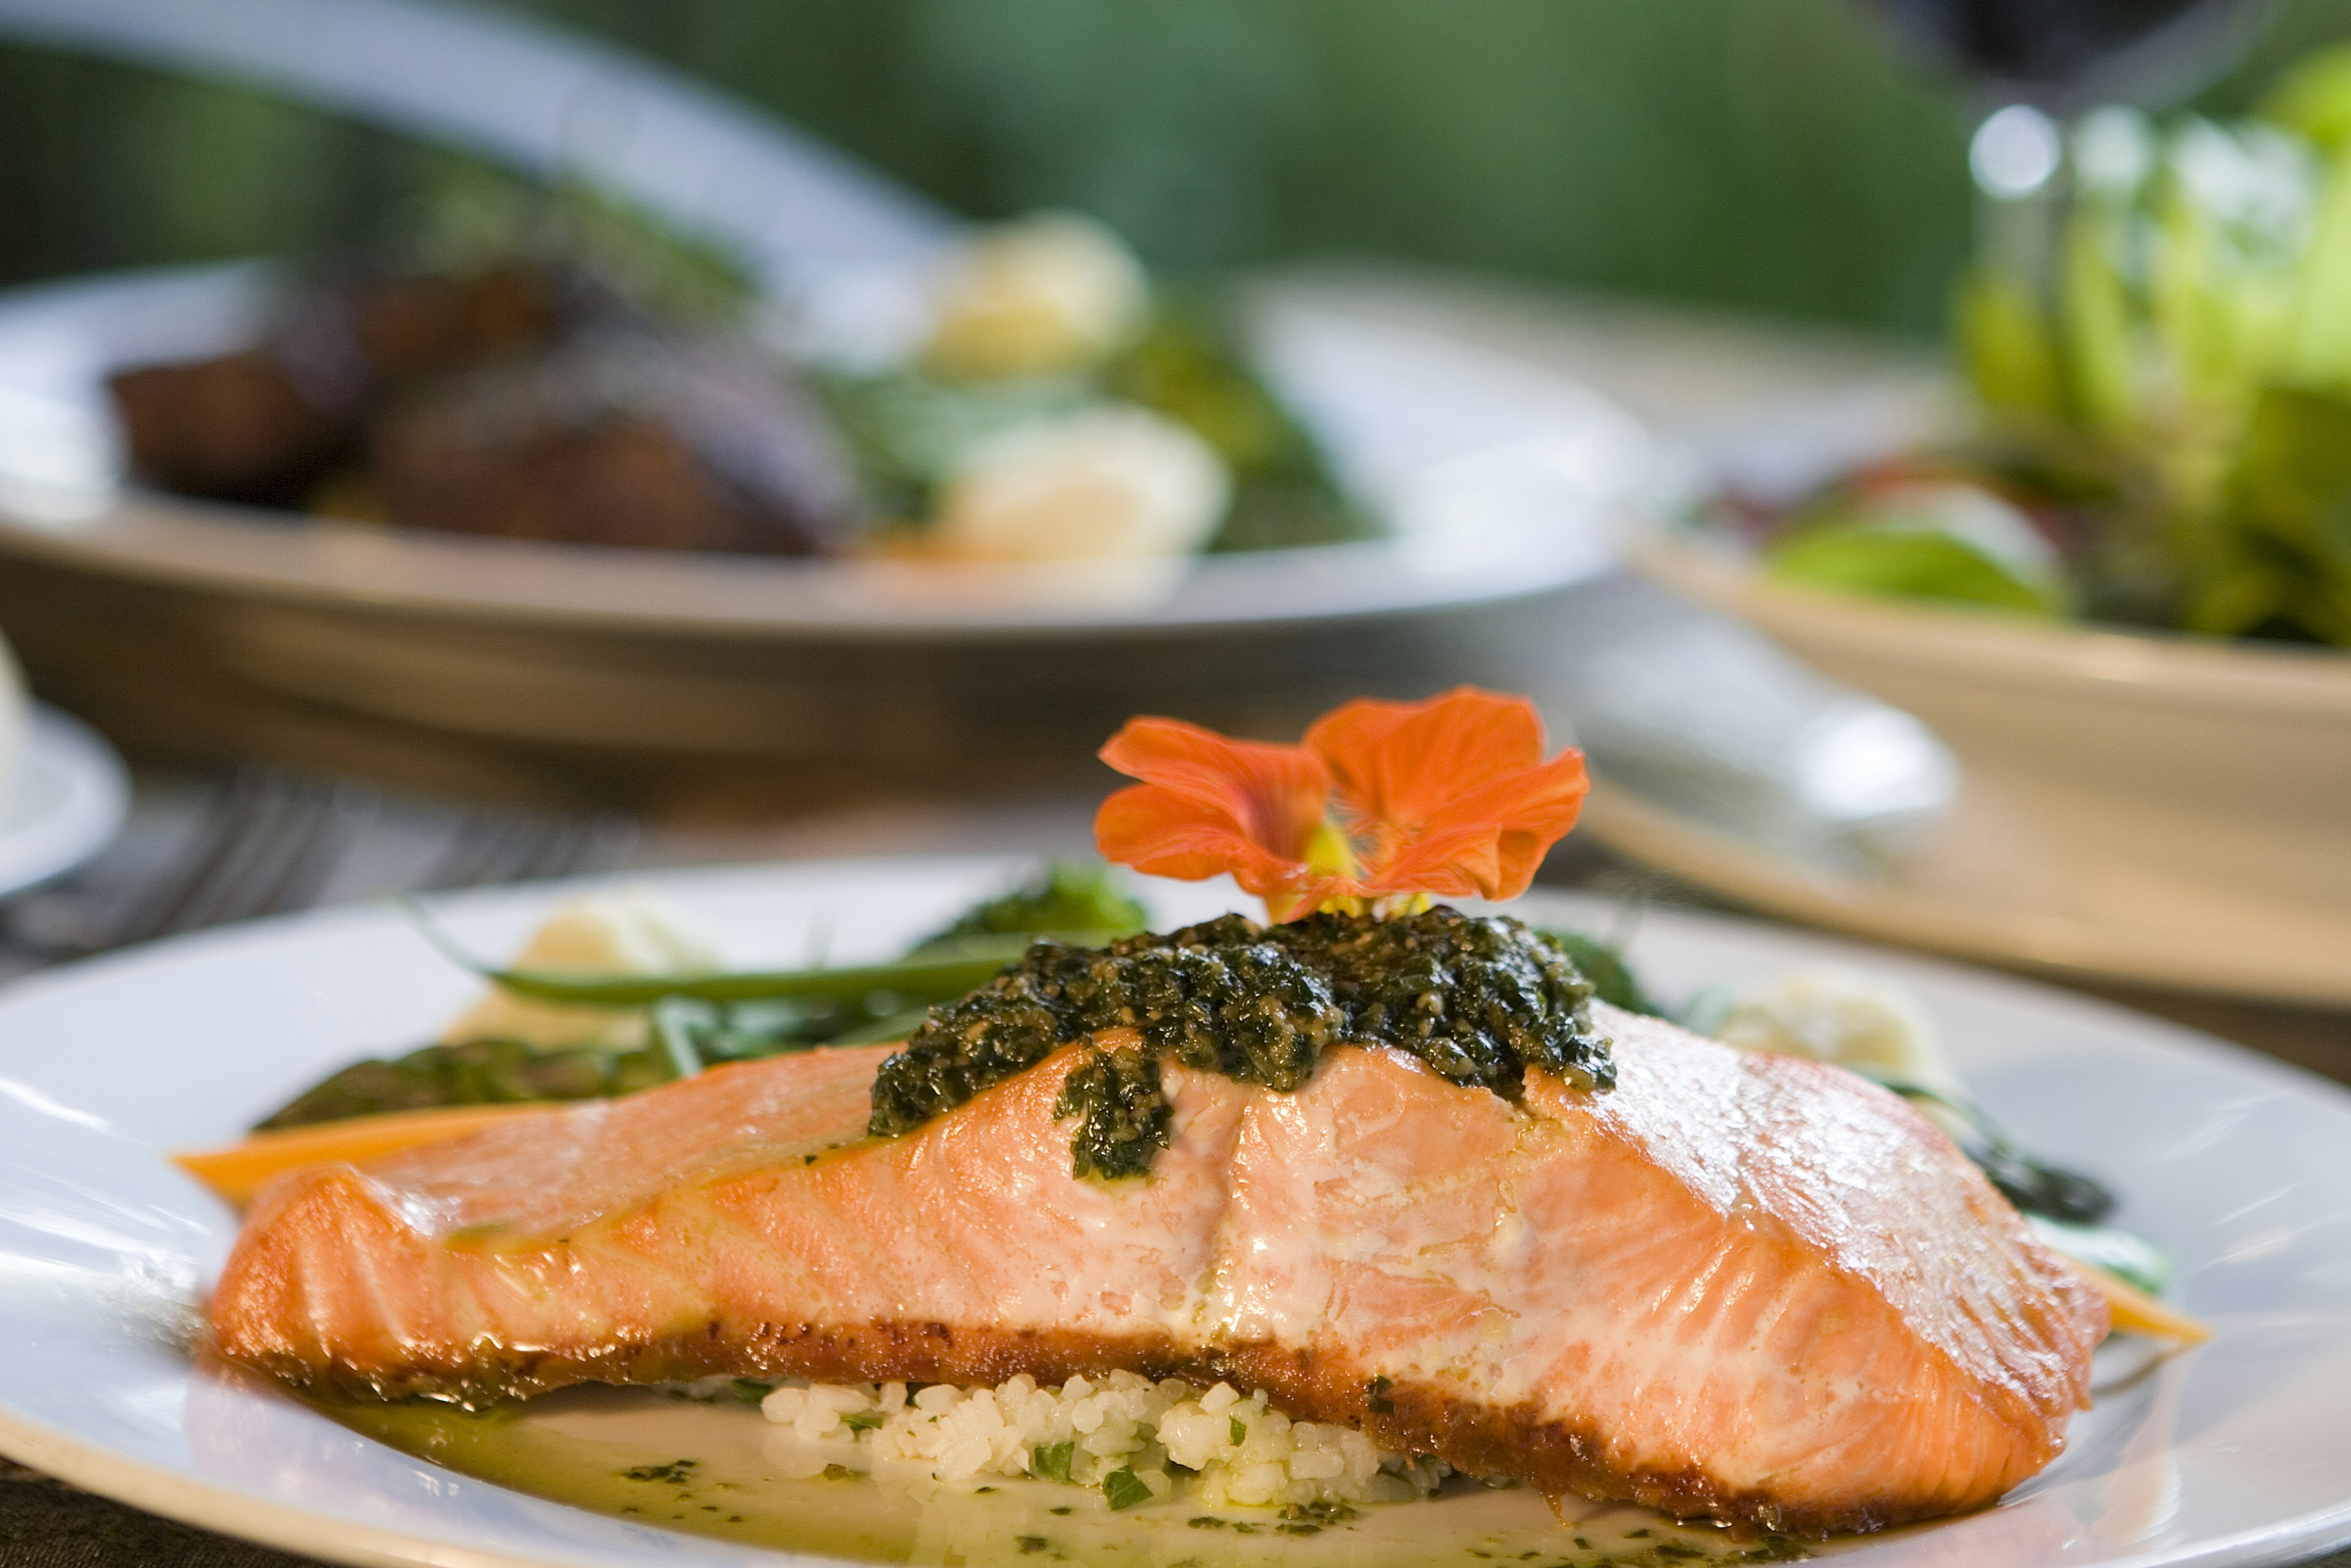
left=0, top=261, right=1648, bottom=644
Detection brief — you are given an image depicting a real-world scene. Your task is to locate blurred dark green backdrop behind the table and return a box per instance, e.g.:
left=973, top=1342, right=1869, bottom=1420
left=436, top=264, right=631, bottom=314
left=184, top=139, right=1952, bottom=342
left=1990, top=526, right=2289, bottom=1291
left=0, top=0, right=2351, bottom=334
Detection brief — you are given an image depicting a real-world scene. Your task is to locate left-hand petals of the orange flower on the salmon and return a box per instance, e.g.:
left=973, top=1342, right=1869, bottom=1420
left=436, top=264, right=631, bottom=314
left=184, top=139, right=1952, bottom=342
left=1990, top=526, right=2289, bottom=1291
left=1093, top=719, right=1330, bottom=907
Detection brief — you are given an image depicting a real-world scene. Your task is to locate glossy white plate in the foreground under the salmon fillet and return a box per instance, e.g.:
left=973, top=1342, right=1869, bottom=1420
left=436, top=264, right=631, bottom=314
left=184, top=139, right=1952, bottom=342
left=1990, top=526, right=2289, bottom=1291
left=0, top=860, right=2351, bottom=1568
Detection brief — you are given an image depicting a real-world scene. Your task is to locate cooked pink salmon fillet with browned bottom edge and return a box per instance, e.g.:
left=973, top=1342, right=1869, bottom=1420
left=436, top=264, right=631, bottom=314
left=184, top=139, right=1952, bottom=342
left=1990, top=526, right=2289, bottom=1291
left=212, top=1006, right=2107, bottom=1532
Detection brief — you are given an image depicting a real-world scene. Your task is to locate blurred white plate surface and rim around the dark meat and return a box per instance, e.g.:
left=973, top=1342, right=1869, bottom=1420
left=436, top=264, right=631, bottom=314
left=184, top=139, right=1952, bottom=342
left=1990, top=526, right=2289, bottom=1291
left=0, top=266, right=1648, bottom=642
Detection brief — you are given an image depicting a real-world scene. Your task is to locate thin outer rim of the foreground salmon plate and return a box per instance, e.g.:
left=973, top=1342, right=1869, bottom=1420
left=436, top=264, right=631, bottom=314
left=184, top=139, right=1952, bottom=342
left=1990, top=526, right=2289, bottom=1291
left=0, top=853, right=2351, bottom=1568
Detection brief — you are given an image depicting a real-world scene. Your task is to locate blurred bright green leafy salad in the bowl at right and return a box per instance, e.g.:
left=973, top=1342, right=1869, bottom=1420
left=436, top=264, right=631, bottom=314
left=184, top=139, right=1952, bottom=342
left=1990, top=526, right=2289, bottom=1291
left=1707, top=50, right=2351, bottom=647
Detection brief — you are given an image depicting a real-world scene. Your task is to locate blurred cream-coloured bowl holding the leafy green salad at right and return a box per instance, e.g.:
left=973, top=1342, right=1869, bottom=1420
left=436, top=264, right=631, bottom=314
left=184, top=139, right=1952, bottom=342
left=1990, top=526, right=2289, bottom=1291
left=1632, top=531, right=2351, bottom=1004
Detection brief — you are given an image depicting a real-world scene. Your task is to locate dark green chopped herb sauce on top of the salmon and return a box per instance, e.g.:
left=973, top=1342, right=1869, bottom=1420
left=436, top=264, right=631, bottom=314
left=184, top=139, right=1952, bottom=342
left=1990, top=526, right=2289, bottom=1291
left=870, top=905, right=1615, bottom=1176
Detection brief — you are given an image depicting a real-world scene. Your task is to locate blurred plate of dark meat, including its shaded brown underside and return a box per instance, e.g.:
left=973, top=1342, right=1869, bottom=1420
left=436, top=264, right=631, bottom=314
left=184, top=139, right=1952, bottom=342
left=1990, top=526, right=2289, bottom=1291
left=0, top=268, right=1646, bottom=799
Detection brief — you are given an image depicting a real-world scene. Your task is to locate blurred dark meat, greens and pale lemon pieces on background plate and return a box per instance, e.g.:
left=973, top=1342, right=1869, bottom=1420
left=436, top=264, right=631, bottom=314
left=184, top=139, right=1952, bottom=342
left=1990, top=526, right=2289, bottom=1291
left=110, top=179, right=1371, bottom=562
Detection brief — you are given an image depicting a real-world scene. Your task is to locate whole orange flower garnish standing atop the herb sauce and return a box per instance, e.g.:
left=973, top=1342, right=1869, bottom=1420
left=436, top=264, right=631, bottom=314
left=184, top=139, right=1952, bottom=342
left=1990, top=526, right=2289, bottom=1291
left=1093, top=686, right=1587, bottom=919
